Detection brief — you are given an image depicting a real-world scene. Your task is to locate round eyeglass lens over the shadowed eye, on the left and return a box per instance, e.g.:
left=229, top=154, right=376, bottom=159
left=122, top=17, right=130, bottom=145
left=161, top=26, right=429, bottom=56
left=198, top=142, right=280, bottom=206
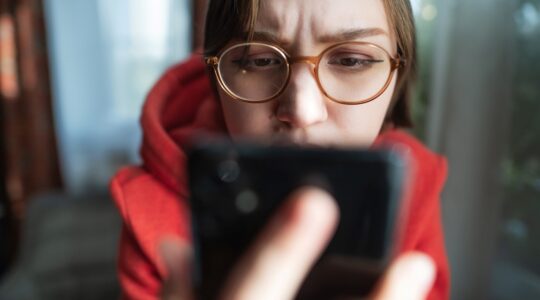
left=218, top=43, right=289, bottom=102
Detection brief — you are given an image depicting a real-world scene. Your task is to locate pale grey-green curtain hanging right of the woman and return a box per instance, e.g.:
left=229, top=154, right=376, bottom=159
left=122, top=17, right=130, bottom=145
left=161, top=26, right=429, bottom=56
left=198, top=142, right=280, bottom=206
left=427, top=0, right=520, bottom=299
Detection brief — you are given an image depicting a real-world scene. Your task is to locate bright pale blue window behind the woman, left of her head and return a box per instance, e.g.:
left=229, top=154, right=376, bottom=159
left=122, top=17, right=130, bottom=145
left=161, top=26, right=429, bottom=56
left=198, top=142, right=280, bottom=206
left=45, top=0, right=191, bottom=192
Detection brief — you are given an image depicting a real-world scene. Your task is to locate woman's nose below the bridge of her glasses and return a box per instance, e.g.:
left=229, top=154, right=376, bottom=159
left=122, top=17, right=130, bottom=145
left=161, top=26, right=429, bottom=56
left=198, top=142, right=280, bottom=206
left=276, top=64, right=328, bottom=128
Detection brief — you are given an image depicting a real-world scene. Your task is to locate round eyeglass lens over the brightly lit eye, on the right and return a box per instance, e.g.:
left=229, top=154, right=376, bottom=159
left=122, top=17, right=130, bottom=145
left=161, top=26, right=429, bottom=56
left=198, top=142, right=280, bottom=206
left=318, top=43, right=391, bottom=103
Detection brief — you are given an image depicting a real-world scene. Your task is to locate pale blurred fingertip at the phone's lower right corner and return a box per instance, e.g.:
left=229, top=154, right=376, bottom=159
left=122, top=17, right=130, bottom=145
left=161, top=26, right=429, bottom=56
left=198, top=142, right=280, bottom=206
left=371, top=252, right=435, bottom=300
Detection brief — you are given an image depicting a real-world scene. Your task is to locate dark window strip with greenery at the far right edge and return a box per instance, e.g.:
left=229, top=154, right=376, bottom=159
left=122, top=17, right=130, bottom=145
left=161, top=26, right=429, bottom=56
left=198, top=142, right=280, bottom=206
left=492, top=0, right=540, bottom=299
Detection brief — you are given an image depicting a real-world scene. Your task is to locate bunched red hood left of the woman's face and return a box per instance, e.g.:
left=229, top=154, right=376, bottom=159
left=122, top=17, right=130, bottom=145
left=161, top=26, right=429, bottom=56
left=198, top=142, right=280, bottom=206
left=140, top=55, right=225, bottom=195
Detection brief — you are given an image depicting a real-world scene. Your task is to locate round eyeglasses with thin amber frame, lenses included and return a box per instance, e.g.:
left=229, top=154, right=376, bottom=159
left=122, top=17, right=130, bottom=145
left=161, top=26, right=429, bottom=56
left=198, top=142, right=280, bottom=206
left=205, top=42, right=405, bottom=105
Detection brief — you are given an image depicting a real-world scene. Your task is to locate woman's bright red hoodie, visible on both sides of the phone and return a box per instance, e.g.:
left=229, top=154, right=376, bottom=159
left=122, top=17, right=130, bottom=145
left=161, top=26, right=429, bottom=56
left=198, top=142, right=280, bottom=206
left=111, top=56, right=449, bottom=299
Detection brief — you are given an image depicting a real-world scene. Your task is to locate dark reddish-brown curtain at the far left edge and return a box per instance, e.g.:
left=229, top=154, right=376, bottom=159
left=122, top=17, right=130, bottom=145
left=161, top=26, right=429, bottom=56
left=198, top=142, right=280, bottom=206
left=0, top=0, right=62, bottom=272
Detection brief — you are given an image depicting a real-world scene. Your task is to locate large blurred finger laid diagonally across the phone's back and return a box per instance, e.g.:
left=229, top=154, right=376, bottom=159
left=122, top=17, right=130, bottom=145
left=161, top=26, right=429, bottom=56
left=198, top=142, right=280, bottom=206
left=219, top=188, right=338, bottom=299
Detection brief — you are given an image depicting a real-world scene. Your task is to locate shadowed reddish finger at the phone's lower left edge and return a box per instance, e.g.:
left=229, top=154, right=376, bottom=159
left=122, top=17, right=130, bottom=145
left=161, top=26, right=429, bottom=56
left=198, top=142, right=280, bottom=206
left=159, top=238, right=193, bottom=300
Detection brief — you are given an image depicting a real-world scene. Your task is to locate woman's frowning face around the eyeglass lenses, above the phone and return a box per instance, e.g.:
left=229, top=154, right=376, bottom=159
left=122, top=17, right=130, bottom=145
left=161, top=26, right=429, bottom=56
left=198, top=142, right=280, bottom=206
left=218, top=0, right=397, bottom=147
